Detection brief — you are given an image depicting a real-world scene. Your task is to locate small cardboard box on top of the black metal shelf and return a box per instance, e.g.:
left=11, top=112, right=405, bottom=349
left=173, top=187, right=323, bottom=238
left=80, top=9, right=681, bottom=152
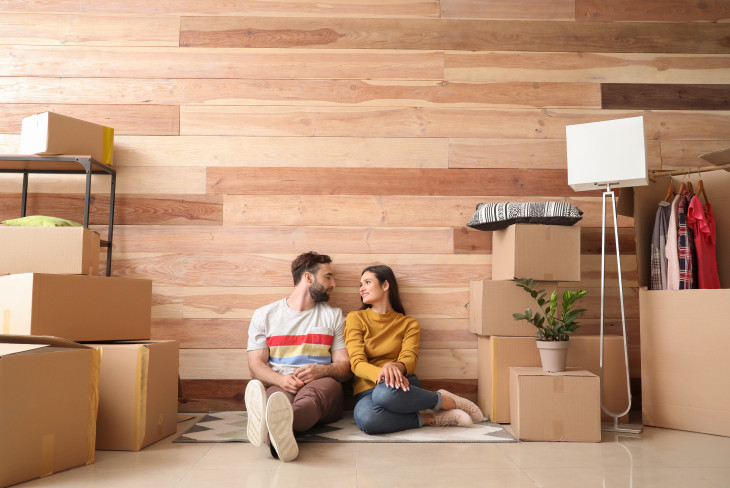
left=20, top=112, right=114, bottom=165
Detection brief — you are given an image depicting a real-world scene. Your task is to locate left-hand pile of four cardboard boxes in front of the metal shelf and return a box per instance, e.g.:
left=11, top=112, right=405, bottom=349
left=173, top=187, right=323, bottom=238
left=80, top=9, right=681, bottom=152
left=0, top=221, right=178, bottom=487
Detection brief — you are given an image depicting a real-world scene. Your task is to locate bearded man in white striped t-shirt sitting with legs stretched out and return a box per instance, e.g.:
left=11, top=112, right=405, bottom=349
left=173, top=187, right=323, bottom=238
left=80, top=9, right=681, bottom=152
left=245, top=252, right=351, bottom=461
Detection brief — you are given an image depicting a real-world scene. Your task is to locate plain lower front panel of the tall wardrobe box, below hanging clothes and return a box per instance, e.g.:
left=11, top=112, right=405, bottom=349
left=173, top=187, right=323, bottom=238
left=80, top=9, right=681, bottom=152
left=639, top=288, right=730, bottom=436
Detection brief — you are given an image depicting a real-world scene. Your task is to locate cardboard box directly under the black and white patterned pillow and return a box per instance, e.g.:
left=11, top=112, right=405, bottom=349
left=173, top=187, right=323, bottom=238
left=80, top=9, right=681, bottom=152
left=492, top=224, right=580, bottom=281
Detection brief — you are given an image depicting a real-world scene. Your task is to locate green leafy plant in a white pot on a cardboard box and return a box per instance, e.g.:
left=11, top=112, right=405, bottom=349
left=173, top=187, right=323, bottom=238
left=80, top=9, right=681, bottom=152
left=512, top=278, right=587, bottom=372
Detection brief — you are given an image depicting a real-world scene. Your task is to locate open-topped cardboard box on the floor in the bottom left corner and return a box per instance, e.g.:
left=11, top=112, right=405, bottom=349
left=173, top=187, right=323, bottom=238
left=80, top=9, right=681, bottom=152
left=0, top=335, right=99, bottom=487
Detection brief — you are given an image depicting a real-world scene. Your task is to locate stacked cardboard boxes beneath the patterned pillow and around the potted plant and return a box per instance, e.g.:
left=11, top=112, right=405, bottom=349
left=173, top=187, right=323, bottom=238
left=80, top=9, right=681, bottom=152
left=469, top=224, right=628, bottom=442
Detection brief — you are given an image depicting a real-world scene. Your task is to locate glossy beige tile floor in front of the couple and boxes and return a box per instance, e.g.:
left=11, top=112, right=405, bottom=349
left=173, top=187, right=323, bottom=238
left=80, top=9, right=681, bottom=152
left=20, top=420, right=730, bottom=488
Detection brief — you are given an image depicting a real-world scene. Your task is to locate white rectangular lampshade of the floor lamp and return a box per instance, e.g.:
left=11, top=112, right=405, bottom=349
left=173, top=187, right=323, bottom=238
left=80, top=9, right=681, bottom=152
left=565, top=117, right=649, bottom=191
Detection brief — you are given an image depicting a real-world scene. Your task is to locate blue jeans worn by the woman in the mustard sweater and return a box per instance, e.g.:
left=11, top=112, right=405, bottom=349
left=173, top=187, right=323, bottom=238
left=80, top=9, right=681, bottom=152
left=354, top=375, right=441, bottom=434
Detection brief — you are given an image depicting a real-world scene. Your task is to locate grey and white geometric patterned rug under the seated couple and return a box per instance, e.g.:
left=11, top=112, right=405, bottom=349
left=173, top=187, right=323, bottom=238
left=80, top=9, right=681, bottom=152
left=173, top=411, right=517, bottom=442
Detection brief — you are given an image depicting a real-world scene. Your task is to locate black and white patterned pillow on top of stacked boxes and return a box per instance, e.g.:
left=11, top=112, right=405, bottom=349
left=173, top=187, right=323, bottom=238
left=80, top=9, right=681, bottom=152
left=466, top=202, right=583, bottom=230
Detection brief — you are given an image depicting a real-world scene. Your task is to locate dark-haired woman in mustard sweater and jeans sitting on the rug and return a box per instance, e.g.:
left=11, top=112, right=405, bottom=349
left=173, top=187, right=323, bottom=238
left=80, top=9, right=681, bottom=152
left=345, top=265, right=483, bottom=434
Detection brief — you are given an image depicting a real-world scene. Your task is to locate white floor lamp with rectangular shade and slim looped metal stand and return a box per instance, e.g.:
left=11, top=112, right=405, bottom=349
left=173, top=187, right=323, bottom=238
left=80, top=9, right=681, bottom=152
left=565, top=117, right=649, bottom=434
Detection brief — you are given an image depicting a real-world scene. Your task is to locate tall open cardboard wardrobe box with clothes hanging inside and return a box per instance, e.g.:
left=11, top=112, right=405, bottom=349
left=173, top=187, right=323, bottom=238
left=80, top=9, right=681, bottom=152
left=618, top=170, right=730, bottom=436
